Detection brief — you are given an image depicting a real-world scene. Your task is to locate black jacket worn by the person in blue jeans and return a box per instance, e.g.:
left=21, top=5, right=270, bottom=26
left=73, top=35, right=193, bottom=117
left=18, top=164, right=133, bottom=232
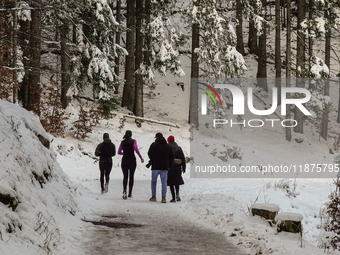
left=148, top=137, right=174, bottom=170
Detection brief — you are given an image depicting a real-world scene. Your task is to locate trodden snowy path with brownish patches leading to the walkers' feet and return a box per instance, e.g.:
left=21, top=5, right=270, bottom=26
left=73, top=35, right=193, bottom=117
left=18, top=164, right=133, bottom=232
left=73, top=179, right=247, bottom=255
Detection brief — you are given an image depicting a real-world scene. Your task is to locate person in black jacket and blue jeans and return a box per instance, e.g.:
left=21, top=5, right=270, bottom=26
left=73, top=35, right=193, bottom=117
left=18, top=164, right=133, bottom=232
left=148, top=133, right=174, bottom=203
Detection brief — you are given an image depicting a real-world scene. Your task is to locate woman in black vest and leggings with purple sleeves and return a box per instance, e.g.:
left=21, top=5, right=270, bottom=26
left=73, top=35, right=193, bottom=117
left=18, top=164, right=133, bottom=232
left=118, top=130, right=144, bottom=199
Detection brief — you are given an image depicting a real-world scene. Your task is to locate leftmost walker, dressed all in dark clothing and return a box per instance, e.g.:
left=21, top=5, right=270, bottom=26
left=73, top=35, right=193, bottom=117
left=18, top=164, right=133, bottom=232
left=94, top=133, right=116, bottom=194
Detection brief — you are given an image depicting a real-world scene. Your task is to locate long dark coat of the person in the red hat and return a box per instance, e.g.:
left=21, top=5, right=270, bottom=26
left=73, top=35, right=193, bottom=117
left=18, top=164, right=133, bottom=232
left=168, top=142, right=186, bottom=186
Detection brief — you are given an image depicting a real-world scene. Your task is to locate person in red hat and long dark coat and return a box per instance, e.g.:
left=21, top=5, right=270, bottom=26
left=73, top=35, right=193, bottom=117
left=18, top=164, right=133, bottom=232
left=168, top=135, right=186, bottom=203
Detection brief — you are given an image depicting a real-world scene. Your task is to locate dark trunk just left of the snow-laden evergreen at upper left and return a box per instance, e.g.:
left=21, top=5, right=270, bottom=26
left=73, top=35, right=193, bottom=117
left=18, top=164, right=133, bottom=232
left=60, top=19, right=70, bottom=109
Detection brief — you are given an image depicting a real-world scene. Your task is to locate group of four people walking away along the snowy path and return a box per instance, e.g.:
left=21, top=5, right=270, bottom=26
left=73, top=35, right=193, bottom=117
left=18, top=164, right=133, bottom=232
left=95, top=130, right=186, bottom=203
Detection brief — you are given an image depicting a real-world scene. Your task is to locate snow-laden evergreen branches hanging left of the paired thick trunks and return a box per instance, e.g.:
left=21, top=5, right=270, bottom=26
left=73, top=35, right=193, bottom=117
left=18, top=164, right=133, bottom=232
left=71, top=0, right=127, bottom=114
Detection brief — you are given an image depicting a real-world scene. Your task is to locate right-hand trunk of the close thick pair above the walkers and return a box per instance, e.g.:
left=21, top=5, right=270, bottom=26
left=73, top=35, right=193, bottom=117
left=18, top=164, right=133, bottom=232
left=134, top=0, right=144, bottom=117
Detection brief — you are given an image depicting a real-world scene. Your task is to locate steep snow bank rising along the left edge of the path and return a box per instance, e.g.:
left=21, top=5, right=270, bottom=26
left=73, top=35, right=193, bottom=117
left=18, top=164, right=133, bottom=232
left=0, top=100, right=76, bottom=255
